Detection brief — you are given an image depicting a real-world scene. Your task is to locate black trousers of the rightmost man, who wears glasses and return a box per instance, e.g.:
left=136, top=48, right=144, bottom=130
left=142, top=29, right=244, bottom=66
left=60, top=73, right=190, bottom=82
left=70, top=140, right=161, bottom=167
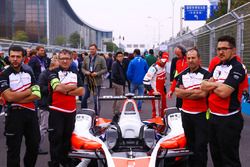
left=209, top=112, right=244, bottom=167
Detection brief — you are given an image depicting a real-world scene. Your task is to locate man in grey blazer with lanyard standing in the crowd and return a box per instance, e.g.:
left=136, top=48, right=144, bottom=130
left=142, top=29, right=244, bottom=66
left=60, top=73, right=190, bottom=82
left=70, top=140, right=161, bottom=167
left=81, top=44, right=107, bottom=115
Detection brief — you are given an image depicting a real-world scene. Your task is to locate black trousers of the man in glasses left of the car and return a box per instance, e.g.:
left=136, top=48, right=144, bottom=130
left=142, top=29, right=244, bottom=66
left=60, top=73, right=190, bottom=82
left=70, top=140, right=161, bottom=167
left=49, top=110, right=76, bottom=167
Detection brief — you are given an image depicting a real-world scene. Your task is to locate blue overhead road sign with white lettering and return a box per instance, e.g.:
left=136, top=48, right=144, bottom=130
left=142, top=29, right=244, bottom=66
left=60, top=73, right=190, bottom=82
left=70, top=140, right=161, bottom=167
left=184, top=5, right=207, bottom=21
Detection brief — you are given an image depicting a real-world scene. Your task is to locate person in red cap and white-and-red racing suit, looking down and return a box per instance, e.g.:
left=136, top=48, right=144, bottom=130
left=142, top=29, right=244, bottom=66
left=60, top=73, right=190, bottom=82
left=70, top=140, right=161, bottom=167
left=143, top=52, right=169, bottom=118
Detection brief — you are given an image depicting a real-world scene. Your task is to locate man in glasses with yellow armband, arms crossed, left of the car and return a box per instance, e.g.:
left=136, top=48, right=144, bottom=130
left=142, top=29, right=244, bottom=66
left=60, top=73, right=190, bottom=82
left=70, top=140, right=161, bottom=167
left=48, top=50, right=83, bottom=167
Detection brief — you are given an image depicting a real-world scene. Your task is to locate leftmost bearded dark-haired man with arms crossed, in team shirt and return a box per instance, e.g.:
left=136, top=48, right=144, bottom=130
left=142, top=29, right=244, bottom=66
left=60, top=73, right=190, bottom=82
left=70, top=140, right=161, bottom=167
left=0, top=46, right=41, bottom=167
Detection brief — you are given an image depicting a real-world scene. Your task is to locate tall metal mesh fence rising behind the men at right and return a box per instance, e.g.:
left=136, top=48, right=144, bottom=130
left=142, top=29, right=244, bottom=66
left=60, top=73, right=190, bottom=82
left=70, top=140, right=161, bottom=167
left=167, top=2, right=250, bottom=72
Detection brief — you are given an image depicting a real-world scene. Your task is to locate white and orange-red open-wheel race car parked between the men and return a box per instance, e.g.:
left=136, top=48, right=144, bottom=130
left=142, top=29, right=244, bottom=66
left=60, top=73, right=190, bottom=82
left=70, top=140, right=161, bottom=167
left=69, top=94, right=192, bottom=167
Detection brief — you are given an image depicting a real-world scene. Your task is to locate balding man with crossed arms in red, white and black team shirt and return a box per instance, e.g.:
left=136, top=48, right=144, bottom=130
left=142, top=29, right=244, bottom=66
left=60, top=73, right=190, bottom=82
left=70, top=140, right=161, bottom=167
left=175, top=48, right=210, bottom=167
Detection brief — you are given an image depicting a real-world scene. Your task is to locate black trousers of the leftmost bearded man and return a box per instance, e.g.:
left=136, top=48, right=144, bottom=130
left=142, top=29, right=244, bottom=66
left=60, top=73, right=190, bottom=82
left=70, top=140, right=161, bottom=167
left=4, top=109, right=40, bottom=167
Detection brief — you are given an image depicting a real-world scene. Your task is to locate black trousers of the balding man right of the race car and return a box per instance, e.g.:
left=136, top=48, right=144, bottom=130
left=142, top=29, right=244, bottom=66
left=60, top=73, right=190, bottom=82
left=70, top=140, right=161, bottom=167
left=181, top=112, right=208, bottom=167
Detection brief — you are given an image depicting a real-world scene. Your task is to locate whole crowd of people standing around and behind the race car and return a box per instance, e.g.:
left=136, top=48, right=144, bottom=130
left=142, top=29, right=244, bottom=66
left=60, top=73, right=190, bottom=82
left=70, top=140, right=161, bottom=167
left=0, top=36, right=248, bottom=167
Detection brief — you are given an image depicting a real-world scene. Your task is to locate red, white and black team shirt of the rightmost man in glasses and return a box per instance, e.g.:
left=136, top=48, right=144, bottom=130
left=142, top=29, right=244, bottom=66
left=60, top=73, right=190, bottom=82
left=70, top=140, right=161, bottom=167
left=208, top=57, right=246, bottom=116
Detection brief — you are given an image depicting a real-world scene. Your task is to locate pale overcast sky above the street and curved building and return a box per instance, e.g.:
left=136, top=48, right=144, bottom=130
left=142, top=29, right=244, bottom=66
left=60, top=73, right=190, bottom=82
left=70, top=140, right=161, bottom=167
left=68, top=0, right=209, bottom=46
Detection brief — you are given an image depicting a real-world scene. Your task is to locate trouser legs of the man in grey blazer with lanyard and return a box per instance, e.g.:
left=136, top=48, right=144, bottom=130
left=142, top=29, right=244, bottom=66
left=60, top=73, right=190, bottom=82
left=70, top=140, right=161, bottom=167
left=81, top=85, right=101, bottom=115
